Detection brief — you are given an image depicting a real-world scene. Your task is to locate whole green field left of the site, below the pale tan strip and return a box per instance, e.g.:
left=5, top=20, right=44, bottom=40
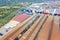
left=0, top=8, right=23, bottom=27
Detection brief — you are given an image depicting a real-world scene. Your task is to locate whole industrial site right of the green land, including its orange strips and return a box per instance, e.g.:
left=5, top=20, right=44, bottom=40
left=0, top=2, right=60, bottom=40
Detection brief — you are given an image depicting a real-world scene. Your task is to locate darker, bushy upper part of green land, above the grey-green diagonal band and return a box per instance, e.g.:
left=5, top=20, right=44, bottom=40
left=0, top=8, right=18, bottom=19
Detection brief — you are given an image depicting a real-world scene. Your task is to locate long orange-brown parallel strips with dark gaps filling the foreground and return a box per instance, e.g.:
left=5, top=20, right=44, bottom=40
left=0, top=14, right=60, bottom=40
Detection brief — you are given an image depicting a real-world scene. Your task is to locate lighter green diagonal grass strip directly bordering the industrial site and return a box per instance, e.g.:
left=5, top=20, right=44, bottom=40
left=0, top=8, right=23, bottom=28
